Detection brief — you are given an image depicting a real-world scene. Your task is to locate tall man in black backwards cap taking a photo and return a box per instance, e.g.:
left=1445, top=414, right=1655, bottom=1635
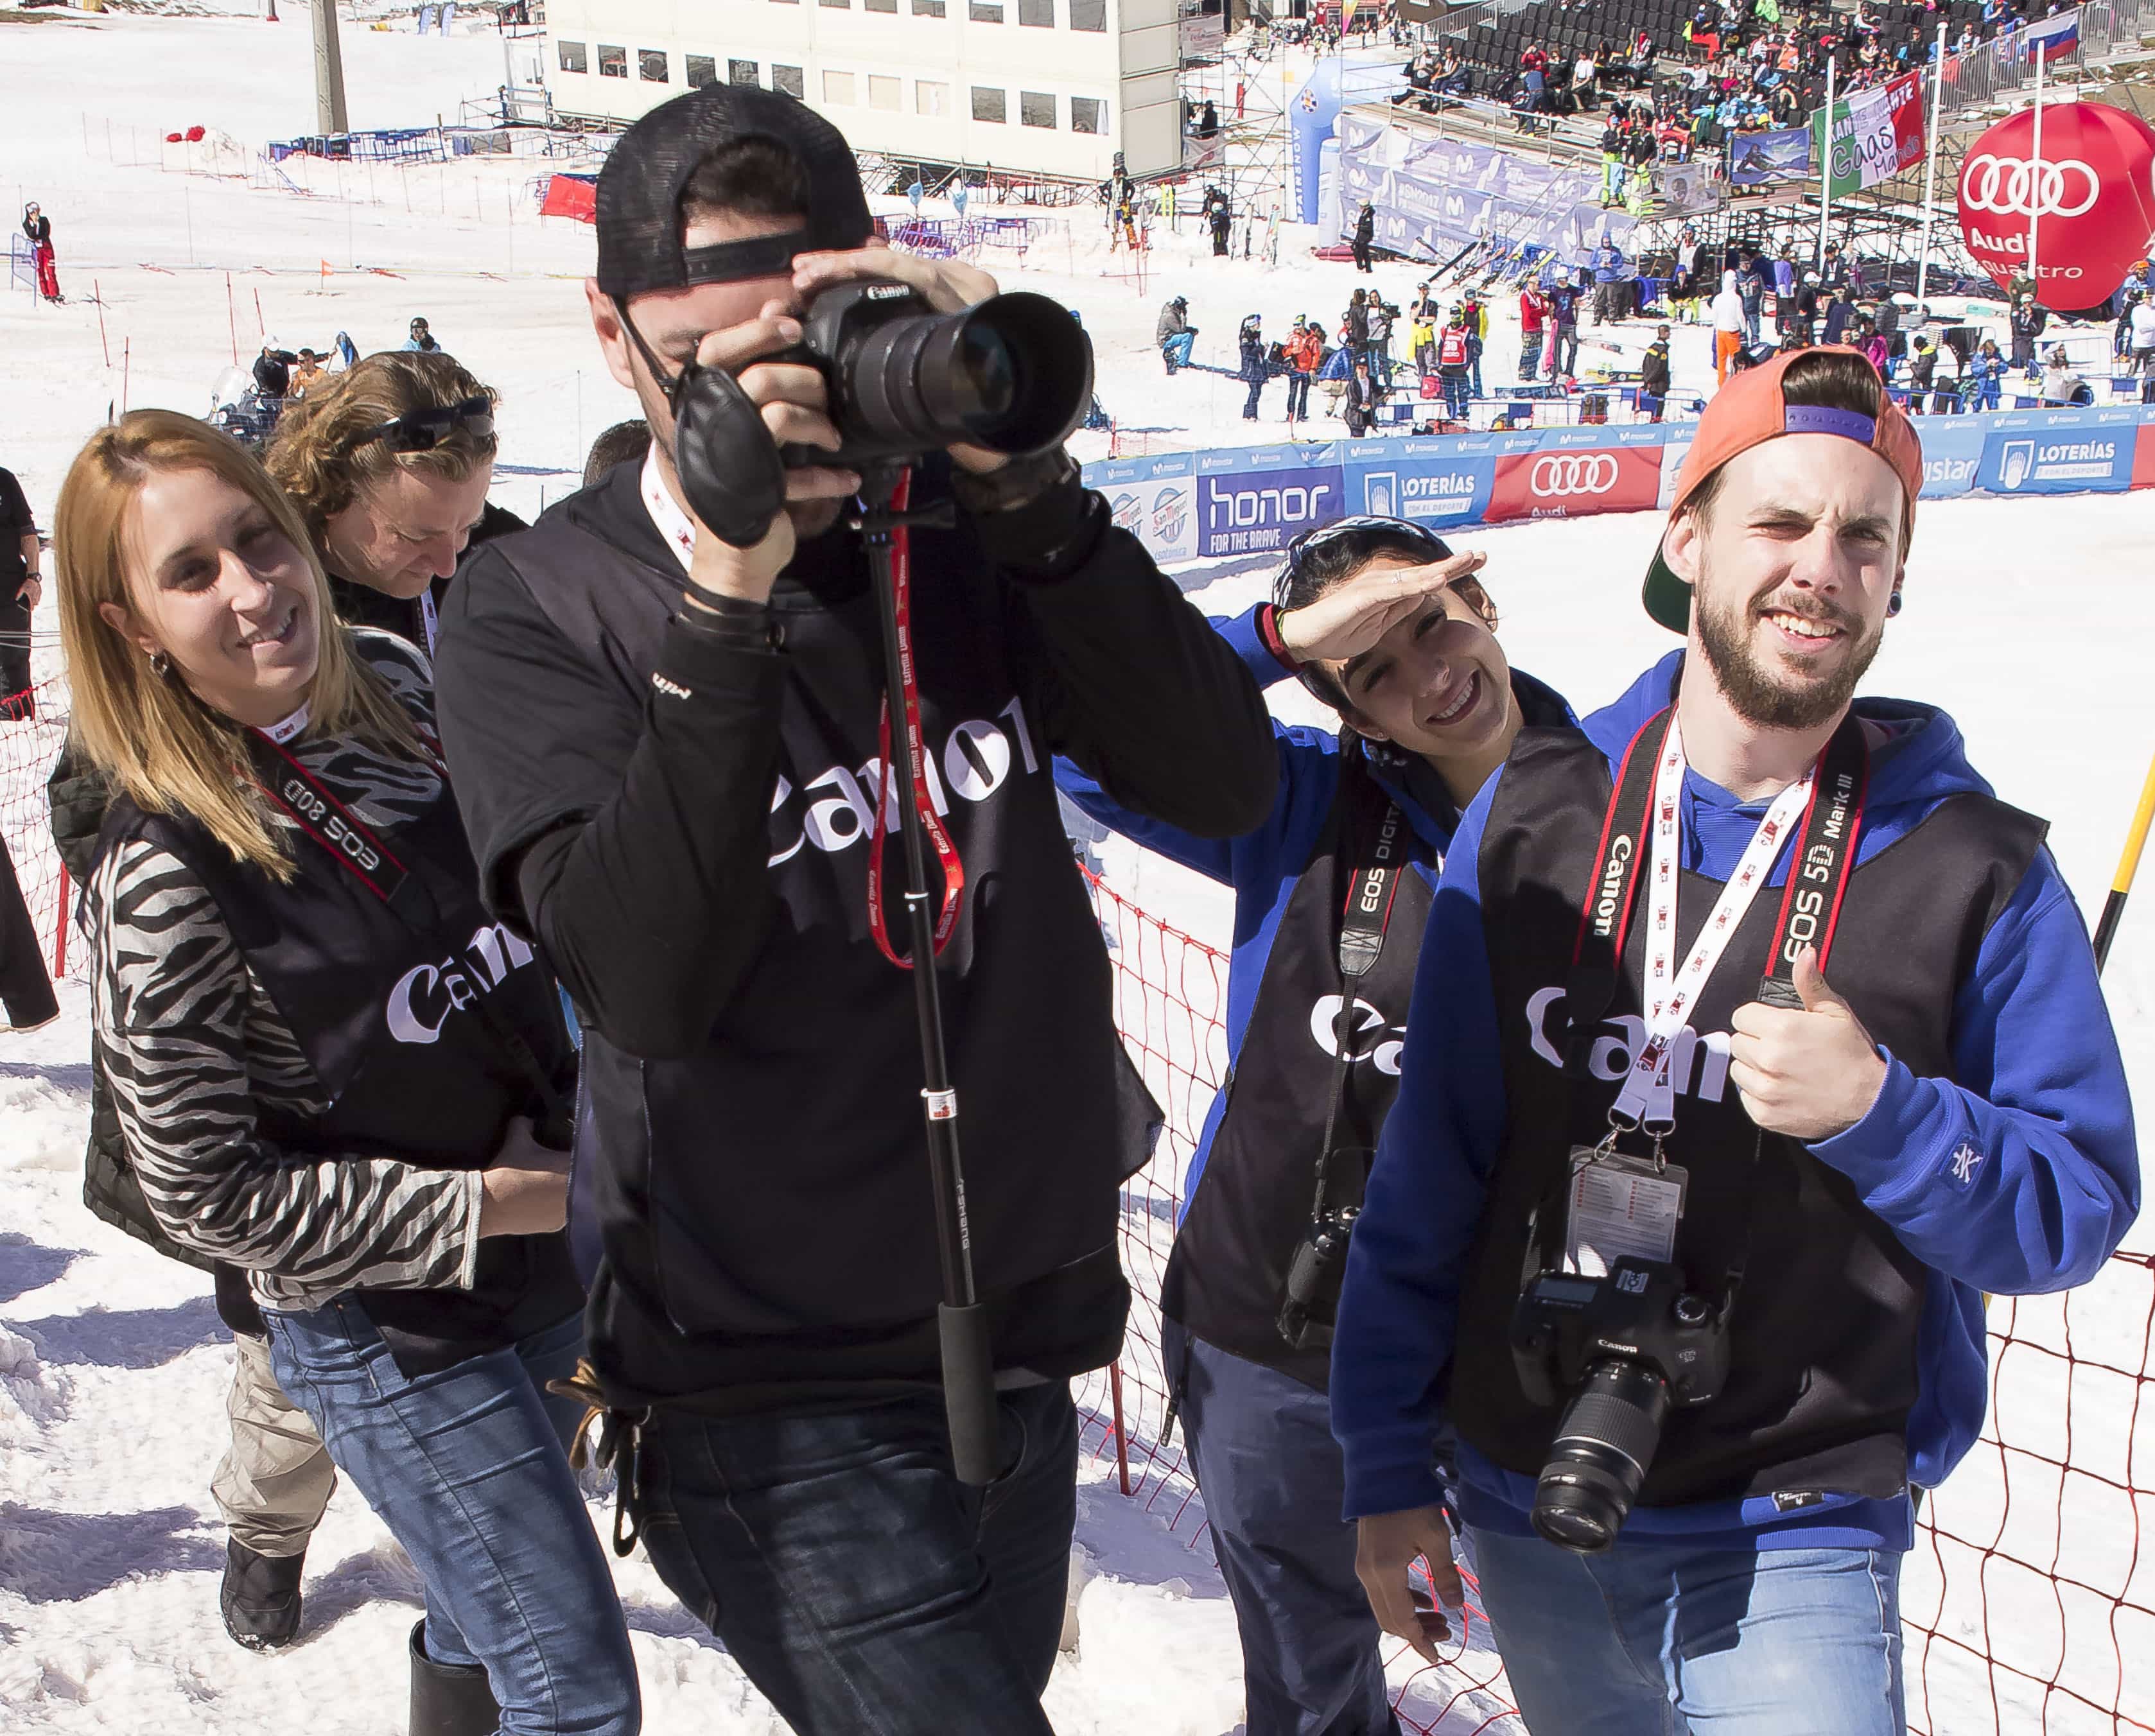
left=437, top=86, right=1278, bottom=1736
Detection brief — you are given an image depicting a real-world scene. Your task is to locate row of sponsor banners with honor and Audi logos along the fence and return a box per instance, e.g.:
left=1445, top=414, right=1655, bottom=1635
left=1084, top=405, right=2155, bottom=564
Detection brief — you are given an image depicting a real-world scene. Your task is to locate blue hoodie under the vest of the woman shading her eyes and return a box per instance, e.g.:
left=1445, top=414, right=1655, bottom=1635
left=1056, top=603, right=1571, bottom=1213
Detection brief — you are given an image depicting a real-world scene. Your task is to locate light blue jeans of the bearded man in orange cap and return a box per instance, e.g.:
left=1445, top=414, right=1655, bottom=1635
left=1467, top=1531, right=1903, bottom=1736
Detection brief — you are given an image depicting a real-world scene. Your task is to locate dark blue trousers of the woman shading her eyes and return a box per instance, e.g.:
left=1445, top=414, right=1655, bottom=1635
left=1160, top=1321, right=1399, bottom=1736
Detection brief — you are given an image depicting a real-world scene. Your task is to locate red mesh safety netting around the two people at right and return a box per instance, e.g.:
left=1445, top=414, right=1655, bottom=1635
left=1079, top=879, right=2155, bottom=1736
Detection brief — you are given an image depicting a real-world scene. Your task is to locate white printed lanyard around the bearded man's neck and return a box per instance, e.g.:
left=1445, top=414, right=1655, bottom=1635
left=1610, top=717, right=1817, bottom=1133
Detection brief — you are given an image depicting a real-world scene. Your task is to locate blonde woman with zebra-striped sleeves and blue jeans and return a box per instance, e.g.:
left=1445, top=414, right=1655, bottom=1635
left=54, top=409, right=638, bottom=1736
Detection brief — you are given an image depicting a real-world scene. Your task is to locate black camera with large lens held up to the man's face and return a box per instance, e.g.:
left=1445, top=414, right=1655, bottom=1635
left=668, top=280, right=1092, bottom=549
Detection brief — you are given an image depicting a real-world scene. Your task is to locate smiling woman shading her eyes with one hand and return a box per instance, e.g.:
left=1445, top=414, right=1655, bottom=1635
left=1056, top=517, right=1571, bottom=1736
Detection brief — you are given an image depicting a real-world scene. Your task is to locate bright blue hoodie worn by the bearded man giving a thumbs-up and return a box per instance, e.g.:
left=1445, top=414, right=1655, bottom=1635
left=1332, top=653, right=2140, bottom=1549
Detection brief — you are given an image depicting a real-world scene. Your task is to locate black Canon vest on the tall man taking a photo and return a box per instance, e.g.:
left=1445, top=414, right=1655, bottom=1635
left=500, top=482, right=1160, bottom=1369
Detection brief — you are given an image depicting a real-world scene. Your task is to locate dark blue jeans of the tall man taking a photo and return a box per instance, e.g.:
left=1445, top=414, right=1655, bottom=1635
left=638, top=1380, right=1078, bottom=1736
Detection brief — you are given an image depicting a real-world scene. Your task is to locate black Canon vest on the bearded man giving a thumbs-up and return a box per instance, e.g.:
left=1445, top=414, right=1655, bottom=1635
left=1448, top=730, right=2045, bottom=1506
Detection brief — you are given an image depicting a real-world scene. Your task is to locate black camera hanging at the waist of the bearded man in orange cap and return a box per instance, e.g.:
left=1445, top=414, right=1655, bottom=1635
left=1511, top=1258, right=1731, bottom=1555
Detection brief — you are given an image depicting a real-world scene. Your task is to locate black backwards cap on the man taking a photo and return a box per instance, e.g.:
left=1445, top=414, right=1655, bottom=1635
left=597, top=84, right=875, bottom=302
